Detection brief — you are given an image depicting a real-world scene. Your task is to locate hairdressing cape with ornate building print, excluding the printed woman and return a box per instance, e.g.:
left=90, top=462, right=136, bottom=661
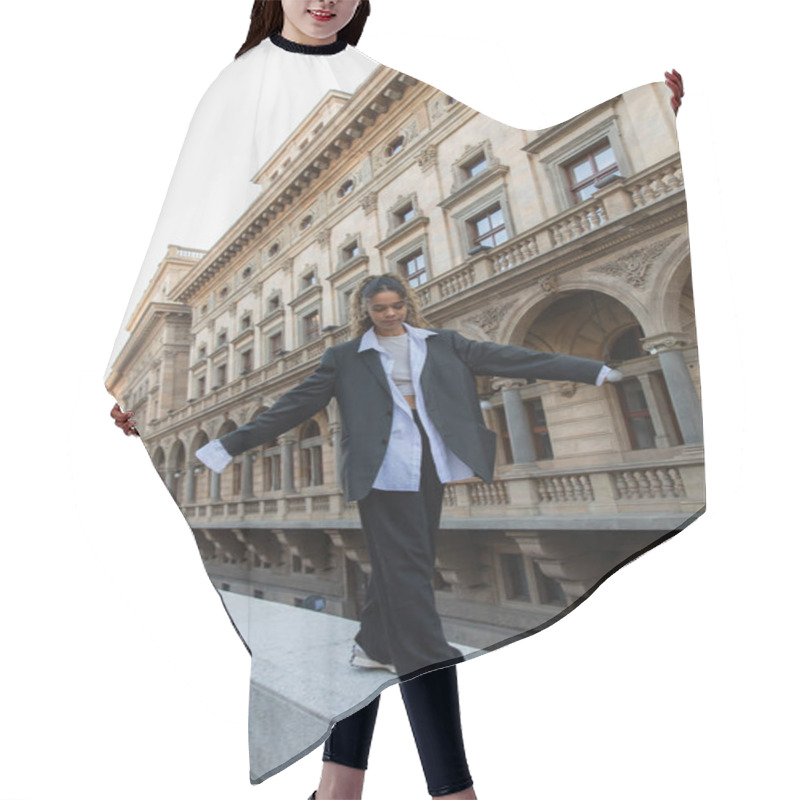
left=106, top=37, right=704, bottom=782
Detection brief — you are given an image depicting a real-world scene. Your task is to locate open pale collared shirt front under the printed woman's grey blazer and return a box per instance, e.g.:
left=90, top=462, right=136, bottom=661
left=358, top=325, right=475, bottom=492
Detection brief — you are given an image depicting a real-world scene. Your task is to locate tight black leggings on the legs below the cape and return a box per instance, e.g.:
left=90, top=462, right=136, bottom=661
left=322, top=667, right=472, bottom=797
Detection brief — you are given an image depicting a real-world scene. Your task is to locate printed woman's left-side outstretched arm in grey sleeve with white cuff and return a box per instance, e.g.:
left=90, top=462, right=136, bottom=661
left=196, top=350, right=336, bottom=472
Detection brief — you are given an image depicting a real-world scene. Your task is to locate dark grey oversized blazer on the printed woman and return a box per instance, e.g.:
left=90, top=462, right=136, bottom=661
left=220, top=330, right=603, bottom=500
